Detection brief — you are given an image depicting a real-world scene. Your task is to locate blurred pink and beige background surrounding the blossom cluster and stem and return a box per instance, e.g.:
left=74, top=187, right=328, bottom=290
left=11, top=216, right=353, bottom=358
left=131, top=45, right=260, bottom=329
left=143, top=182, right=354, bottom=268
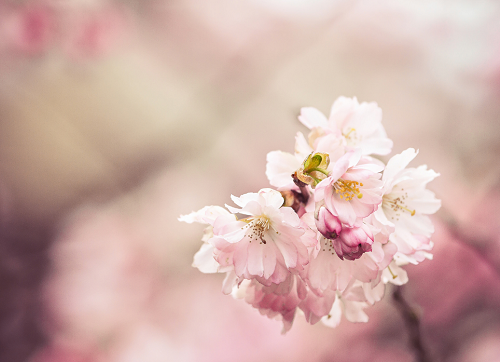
left=0, top=0, right=500, bottom=362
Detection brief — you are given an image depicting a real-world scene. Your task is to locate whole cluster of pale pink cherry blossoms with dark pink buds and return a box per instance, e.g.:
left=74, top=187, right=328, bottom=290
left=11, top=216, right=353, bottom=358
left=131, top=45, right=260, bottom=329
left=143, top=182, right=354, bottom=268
left=179, top=97, right=441, bottom=332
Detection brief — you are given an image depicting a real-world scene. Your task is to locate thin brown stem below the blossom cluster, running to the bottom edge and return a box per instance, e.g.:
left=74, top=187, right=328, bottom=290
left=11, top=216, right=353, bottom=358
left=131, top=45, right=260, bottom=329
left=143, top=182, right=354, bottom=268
left=392, top=286, right=432, bottom=362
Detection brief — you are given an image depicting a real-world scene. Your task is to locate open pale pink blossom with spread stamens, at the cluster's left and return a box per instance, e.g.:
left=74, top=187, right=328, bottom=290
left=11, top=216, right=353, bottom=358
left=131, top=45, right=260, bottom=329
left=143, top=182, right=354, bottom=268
left=209, top=189, right=315, bottom=285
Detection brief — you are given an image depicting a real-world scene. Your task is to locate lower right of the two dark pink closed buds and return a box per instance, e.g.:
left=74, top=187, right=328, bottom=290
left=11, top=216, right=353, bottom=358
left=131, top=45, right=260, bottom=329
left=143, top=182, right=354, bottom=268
left=333, top=224, right=373, bottom=260
